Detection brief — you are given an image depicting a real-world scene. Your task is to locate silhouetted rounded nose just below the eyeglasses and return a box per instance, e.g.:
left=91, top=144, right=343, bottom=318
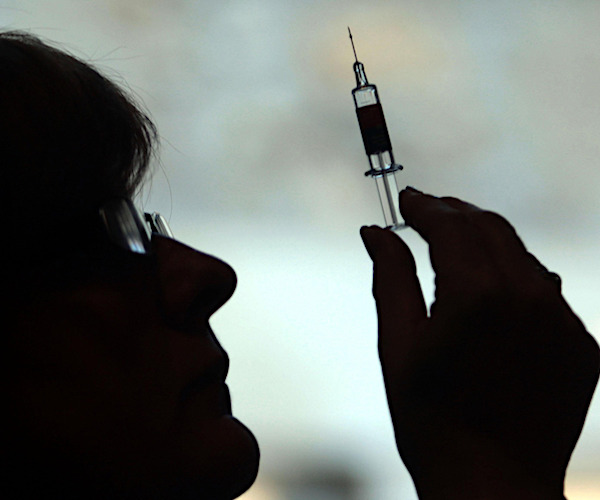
left=152, top=235, right=237, bottom=332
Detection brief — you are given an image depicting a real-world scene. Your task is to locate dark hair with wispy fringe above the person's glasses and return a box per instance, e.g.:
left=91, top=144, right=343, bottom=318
left=0, top=31, right=157, bottom=261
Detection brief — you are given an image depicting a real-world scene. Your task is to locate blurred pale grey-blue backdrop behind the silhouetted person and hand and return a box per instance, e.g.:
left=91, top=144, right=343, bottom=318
left=0, top=0, right=600, bottom=500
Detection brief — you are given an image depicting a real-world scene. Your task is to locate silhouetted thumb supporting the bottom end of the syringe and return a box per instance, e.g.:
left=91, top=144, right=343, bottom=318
left=360, top=226, right=427, bottom=364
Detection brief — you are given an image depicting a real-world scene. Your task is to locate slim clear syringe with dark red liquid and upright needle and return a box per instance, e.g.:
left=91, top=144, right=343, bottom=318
left=348, top=27, right=405, bottom=229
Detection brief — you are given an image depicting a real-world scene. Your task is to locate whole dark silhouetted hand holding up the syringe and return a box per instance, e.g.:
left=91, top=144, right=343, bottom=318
left=361, top=189, right=600, bottom=500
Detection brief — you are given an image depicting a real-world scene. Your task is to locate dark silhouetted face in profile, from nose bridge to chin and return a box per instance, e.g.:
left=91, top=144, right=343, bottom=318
left=11, top=236, right=259, bottom=499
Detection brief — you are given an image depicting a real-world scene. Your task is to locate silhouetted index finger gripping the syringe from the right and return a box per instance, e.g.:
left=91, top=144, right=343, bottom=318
left=400, top=190, right=497, bottom=293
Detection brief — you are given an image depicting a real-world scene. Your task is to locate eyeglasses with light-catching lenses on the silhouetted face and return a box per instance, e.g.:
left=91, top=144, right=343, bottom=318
left=100, top=198, right=173, bottom=254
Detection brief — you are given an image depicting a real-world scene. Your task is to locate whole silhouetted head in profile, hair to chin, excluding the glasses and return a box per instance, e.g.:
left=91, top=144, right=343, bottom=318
left=0, top=32, right=258, bottom=499
